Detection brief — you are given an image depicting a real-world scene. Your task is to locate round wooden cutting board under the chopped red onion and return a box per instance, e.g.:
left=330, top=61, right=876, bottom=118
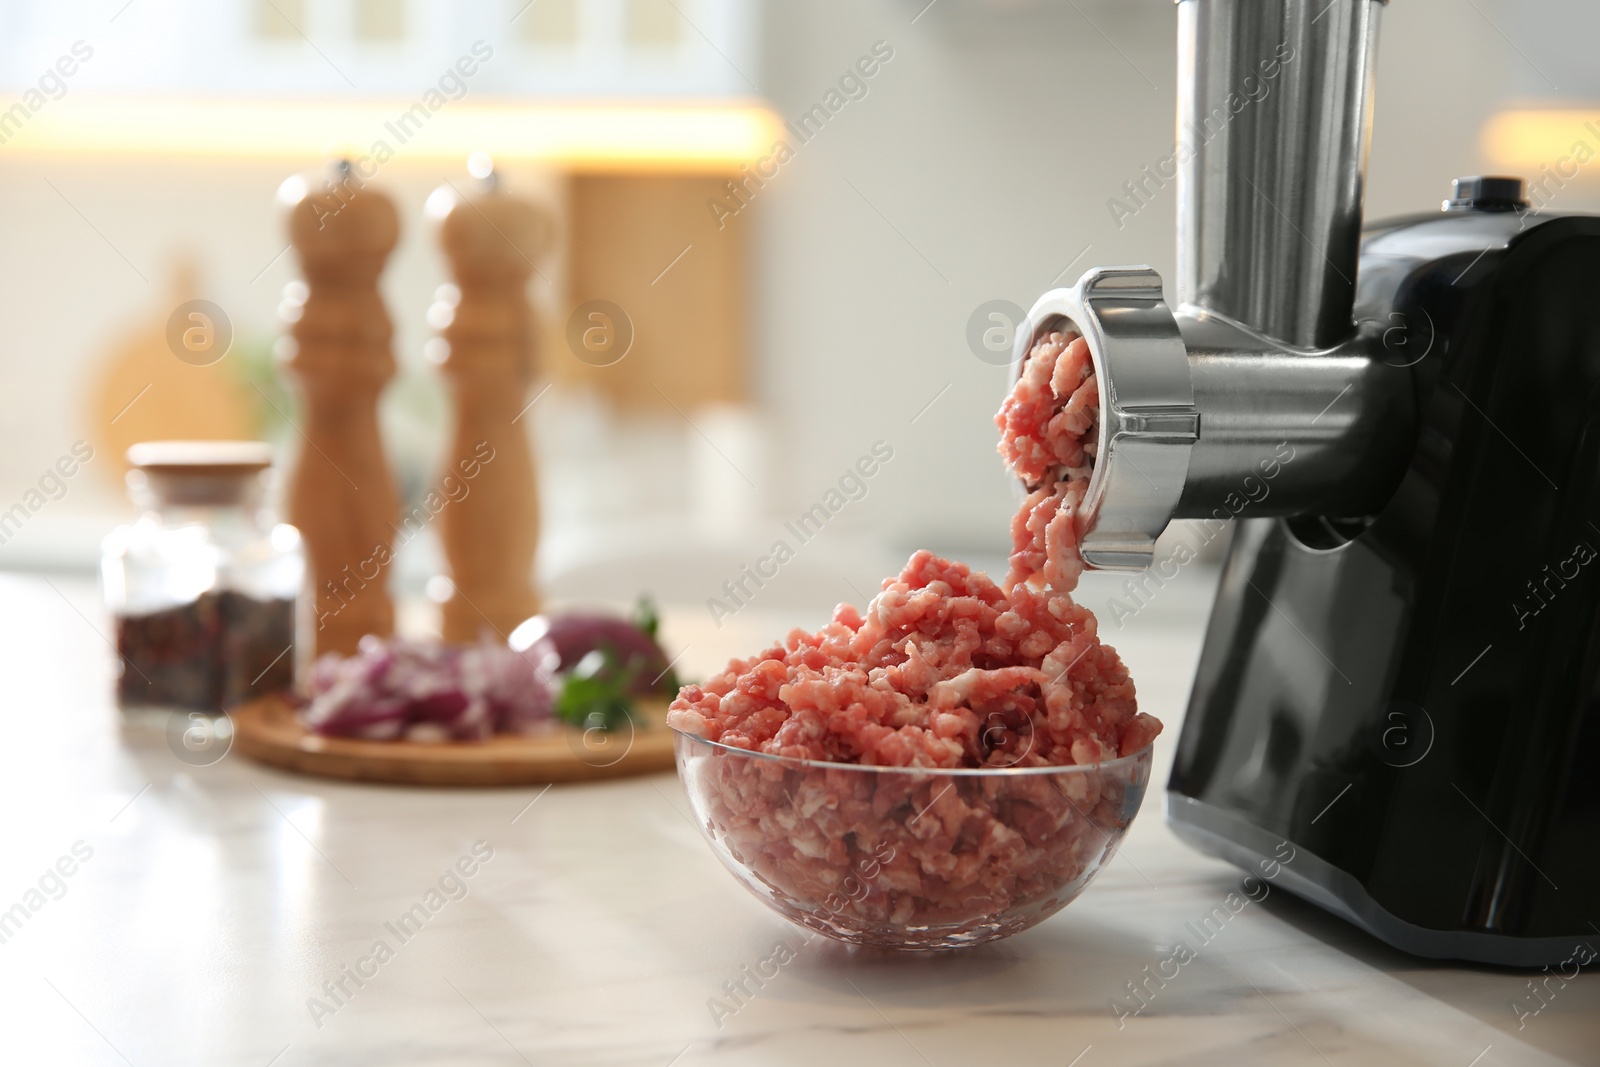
left=230, top=696, right=672, bottom=785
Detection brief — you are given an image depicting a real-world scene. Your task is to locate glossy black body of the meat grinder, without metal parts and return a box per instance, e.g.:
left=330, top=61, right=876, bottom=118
left=1168, top=206, right=1600, bottom=966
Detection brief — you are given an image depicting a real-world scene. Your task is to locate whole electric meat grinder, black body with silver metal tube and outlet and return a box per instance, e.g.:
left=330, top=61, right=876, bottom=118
left=1016, top=0, right=1600, bottom=966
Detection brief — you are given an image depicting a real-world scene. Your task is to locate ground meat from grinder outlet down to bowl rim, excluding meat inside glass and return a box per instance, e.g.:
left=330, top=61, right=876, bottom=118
left=669, top=330, right=1162, bottom=766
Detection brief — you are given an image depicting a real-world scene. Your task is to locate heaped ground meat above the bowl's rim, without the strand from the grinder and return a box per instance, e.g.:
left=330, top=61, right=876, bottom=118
left=667, top=552, right=1160, bottom=768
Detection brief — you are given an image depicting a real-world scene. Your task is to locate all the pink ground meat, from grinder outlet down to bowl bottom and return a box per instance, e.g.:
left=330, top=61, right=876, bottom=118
left=667, top=330, right=1162, bottom=947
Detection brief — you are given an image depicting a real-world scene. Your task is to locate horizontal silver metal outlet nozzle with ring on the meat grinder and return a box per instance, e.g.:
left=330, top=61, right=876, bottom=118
left=1011, top=267, right=1414, bottom=571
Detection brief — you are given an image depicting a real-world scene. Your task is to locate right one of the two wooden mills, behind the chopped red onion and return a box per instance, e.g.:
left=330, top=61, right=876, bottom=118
left=427, top=157, right=555, bottom=641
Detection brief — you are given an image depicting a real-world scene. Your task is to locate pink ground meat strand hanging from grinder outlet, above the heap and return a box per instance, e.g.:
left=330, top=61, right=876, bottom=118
left=995, top=330, right=1099, bottom=592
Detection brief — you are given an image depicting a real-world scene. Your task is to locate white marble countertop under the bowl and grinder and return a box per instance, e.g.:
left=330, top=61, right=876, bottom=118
left=0, top=574, right=1600, bottom=1067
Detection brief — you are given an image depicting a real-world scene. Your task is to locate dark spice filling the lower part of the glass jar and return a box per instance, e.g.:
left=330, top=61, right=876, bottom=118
left=115, top=590, right=294, bottom=712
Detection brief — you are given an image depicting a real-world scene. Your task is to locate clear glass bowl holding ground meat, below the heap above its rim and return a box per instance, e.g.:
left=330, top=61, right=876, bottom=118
left=674, top=733, right=1150, bottom=950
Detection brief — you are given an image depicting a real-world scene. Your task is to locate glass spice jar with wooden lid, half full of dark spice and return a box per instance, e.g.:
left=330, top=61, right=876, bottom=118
left=101, top=442, right=306, bottom=713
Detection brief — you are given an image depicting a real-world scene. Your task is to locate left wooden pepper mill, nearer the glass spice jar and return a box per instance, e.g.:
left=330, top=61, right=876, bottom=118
left=278, top=162, right=400, bottom=654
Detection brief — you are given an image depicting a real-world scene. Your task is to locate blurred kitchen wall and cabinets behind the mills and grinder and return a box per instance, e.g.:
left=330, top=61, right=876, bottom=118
left=0, top=0, right=1600, bottom=621
